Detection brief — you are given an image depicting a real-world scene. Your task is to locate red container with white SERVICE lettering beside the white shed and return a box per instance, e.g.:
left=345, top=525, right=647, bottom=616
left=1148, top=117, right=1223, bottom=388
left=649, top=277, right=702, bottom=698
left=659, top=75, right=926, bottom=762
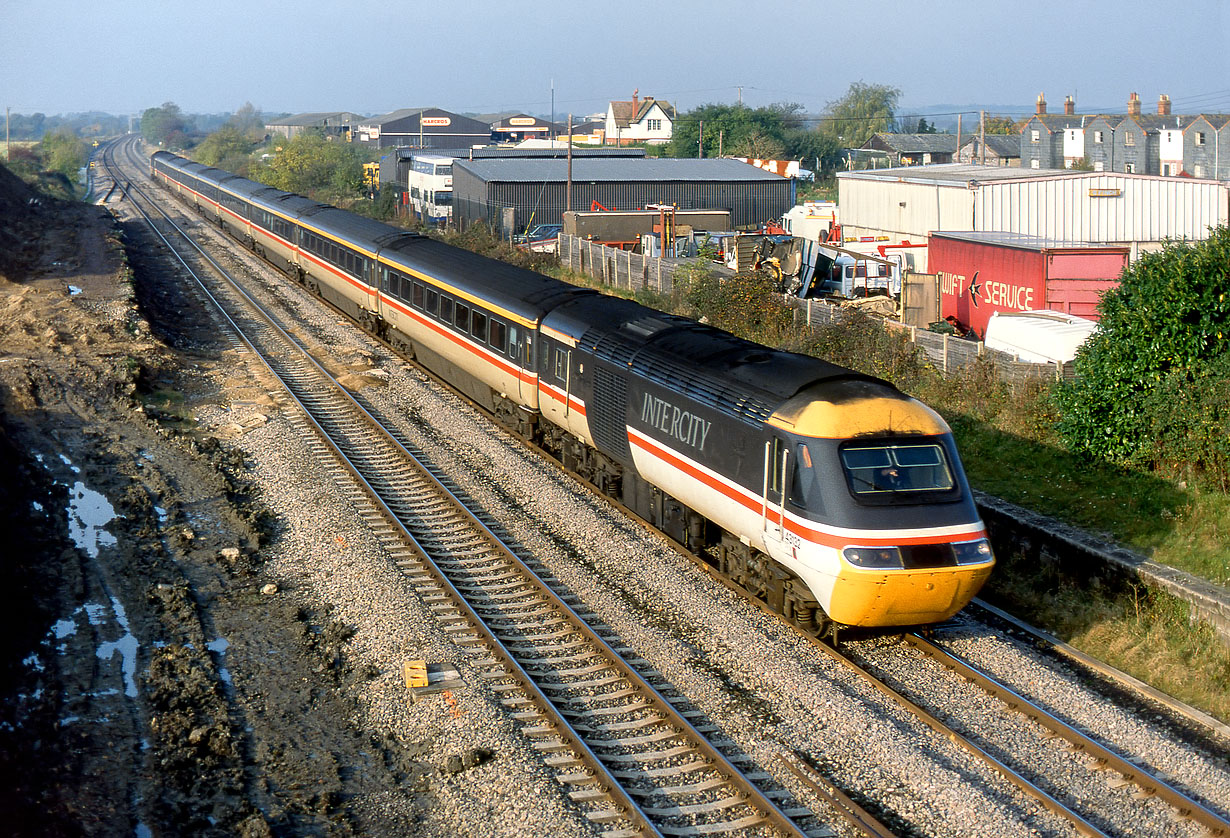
left=927, top=231, right=1130, bottom=337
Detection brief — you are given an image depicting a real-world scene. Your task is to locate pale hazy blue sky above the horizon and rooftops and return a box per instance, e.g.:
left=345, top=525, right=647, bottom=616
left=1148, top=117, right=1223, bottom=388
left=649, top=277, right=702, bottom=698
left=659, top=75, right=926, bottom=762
left=0, top=0, right=1230, bottom=121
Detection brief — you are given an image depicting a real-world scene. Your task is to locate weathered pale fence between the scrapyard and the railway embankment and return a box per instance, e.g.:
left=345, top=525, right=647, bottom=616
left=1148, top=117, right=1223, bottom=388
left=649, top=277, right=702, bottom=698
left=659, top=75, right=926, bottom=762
left=558, top=234, right=1073, bottom=385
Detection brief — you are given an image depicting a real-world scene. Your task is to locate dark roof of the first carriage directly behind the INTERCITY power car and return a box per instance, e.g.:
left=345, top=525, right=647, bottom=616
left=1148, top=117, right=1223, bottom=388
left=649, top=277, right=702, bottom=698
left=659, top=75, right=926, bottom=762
left=380, top=236, right=599, bottom=322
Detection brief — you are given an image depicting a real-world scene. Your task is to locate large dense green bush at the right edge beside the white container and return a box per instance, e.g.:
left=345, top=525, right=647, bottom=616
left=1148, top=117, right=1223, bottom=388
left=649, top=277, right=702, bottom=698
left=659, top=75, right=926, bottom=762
left=1057, top=226, right=1230, bottom=484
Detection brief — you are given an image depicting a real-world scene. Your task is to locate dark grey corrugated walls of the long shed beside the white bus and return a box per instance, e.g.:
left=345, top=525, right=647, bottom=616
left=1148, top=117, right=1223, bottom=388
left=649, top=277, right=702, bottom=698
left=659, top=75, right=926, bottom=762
left=453, top=167, right=795, bottom=234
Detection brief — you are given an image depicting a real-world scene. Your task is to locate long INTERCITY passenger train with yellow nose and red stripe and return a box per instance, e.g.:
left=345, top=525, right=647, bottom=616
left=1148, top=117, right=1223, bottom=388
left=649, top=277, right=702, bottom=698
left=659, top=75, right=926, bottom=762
left=151, top=151, right=994, bottom=632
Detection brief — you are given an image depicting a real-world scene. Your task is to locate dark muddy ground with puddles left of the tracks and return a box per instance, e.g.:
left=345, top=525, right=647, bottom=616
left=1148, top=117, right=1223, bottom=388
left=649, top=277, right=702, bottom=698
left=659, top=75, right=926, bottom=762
left=0, top=163, right=432, bottom=836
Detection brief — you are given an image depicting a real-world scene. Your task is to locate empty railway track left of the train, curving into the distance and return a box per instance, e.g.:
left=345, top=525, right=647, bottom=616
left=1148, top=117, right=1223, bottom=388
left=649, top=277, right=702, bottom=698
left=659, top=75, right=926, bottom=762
left=107, top=137, right=865, bottom=837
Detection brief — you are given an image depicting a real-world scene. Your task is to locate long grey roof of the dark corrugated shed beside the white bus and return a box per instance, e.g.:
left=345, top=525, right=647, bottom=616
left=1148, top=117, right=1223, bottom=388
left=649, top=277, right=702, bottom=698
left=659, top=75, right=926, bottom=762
left=453, top=156, right=782, bottom=183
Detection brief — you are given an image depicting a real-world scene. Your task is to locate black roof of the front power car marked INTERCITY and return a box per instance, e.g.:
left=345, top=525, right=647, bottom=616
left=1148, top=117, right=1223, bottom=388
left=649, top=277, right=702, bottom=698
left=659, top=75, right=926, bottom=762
left=542, top=295, right=875, bottom=422
